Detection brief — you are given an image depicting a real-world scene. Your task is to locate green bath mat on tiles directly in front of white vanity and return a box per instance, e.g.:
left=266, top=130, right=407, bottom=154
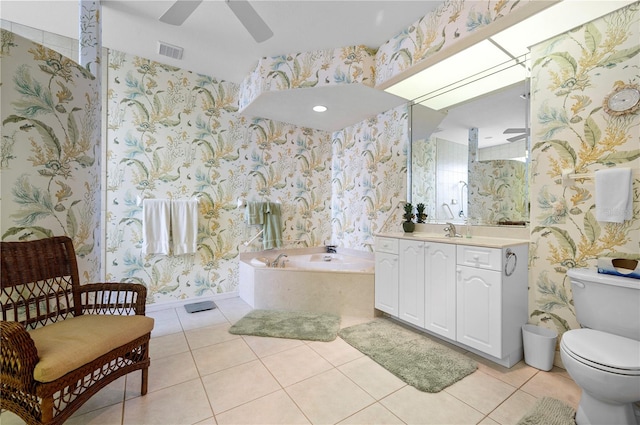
left=338, top=319, right=478, bottom=393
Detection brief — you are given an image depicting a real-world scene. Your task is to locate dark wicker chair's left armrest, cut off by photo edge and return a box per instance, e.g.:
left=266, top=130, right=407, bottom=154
left=0, top=321, right=39, bottom=391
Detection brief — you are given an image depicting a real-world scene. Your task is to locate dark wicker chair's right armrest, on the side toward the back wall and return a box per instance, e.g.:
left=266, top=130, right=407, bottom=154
left=80, top=283, right=147, bottom=316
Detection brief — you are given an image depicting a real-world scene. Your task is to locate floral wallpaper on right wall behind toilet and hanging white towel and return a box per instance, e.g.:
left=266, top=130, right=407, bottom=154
left=529, top=2, right=640, bottom=334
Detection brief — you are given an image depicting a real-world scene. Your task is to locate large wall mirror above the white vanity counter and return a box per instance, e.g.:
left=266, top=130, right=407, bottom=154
left=410, top=80, right=529, bottom=225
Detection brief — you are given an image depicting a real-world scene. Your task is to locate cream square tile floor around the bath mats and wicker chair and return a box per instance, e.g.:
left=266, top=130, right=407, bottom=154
left=0, top=298, right=580, bottom=425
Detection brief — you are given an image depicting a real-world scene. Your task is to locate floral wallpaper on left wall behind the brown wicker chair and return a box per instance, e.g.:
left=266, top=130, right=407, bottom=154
left=0, top=30, right=102, bottom=283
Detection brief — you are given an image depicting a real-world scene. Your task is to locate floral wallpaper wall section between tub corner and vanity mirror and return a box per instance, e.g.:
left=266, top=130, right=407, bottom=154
left=331, top=105, right=409, bottom=251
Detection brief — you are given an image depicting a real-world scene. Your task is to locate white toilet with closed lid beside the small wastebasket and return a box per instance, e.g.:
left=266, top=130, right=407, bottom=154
left=560, top=269, right=640, bottom=425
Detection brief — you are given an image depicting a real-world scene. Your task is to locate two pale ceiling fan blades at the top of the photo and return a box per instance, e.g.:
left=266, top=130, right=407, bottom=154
left=160, top=0, right=273, bottom=43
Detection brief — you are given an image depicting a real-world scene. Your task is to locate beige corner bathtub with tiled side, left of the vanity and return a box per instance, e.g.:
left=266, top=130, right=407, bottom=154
left=239, top=248, right=375, bottom=318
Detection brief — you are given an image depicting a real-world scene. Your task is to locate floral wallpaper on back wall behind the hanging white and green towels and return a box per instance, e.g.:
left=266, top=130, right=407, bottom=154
left=105, top=51, right=331, bottom=303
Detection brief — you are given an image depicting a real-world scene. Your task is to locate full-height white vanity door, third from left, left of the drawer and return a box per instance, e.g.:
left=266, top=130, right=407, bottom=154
left=424, top=242, right=456, bottom=340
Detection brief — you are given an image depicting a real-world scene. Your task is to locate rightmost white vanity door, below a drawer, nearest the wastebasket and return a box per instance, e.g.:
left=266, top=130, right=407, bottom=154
left=457, top=266, right=502, bottom=358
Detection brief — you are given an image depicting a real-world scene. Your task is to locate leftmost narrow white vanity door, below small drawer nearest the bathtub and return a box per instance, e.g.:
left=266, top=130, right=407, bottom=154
left=374, top=238, right=399, bottom=317
